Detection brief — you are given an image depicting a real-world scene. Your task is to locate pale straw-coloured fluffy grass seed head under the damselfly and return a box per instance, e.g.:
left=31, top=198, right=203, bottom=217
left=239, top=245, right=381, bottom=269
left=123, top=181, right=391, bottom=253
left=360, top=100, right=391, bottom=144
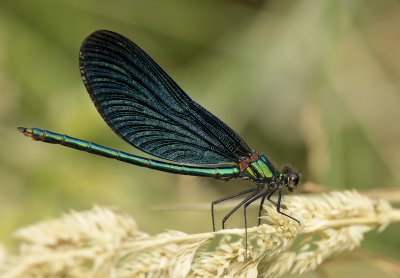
left=0, top=191, right=400, bottom=277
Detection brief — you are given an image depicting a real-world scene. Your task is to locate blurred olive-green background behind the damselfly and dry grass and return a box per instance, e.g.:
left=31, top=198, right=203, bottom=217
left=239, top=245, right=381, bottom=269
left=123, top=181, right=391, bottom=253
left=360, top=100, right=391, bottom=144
left=0, top=0, right=400, bottom=276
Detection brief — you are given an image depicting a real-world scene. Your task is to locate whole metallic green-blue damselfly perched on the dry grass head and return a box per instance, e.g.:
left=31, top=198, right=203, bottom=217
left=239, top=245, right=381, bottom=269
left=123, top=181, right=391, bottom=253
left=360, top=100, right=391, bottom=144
left=18, top=30, right=299, bottom=248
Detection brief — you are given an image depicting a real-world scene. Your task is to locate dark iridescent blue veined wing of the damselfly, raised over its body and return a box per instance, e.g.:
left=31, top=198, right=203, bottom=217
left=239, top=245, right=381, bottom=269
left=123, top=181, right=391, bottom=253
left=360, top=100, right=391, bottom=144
left=80, top=31, right=251, bottom=165
